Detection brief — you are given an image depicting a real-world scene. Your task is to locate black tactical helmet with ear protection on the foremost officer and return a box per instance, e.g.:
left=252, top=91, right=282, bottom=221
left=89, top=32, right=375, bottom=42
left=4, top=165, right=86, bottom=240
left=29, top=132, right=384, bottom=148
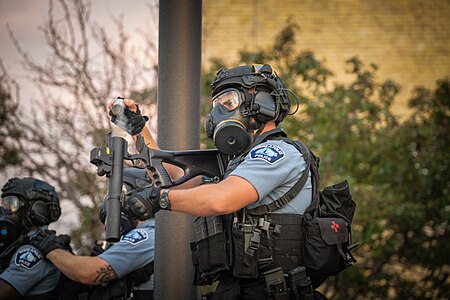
left=211, top=64, right=291, bottom=124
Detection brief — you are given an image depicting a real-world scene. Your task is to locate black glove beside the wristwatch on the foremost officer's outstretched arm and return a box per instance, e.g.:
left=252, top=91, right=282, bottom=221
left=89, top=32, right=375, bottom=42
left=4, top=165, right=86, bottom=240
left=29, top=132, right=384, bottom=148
left=123, top=187, right=160, bottom=221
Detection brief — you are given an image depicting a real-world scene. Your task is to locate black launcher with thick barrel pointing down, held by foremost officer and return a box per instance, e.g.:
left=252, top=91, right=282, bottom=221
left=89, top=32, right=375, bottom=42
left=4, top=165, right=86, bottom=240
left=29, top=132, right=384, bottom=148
left=90, top=134, right=227, bottom=242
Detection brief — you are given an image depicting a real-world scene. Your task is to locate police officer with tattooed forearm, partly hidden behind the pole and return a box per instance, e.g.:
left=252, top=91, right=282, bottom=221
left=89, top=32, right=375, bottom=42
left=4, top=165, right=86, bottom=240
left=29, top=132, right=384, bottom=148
left=31, top=168, right=155, bottom=300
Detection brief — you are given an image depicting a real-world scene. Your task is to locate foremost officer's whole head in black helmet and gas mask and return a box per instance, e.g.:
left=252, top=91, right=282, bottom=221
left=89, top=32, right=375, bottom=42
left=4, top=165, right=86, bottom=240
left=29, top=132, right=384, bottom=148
left=205, top=64, right=291, bottom=155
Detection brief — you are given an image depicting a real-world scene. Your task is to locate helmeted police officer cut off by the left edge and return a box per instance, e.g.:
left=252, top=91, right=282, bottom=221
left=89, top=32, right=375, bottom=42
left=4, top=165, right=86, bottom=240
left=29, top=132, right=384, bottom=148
left=0, top=177, right=63, bottom=299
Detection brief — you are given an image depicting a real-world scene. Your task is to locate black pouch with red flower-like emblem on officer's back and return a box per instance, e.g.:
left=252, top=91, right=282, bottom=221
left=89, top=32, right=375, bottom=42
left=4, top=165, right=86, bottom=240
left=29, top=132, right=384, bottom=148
left=304, top=218, right=348, bottom=275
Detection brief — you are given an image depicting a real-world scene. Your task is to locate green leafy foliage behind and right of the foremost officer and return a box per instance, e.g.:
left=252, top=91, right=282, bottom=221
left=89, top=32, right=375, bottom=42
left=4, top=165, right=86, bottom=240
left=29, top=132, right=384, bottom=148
left=203, top=23, right=450, bottom=299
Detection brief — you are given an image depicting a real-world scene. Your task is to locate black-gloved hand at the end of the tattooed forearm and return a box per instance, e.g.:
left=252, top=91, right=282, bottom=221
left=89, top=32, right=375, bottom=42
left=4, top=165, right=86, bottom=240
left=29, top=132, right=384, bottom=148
left=30, top=229, right=70, bottom=256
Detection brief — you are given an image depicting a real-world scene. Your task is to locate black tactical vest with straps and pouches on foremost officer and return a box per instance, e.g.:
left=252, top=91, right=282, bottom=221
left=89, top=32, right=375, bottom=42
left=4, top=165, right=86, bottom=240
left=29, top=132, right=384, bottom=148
left=191, top=129, right=318, bottom=285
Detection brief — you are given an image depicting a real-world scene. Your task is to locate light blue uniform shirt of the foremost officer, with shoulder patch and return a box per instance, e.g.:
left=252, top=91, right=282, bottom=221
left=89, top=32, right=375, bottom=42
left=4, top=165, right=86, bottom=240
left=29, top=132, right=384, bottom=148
left=229, top=140, right=312, bottom=214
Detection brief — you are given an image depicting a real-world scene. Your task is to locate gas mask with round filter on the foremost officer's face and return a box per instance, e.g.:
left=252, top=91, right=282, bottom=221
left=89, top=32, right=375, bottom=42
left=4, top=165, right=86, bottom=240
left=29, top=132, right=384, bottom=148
left=205, top=88, right=253, bottom=155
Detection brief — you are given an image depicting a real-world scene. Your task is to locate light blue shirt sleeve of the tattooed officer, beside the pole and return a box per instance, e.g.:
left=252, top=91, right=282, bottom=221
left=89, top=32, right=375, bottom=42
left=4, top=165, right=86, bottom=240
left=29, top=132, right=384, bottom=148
left=99, top=219, right=155, bottom=290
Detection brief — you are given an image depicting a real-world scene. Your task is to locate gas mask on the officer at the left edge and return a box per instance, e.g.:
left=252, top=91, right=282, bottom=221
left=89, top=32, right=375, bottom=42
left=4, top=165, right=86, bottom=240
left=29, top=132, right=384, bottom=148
left=0, top=195, right=26, bottom=246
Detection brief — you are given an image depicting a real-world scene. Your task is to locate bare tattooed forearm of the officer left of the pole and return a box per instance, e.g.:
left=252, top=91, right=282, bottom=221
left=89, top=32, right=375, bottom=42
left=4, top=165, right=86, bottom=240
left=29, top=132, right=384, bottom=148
left=47, top=249, right=117, bottom=285
